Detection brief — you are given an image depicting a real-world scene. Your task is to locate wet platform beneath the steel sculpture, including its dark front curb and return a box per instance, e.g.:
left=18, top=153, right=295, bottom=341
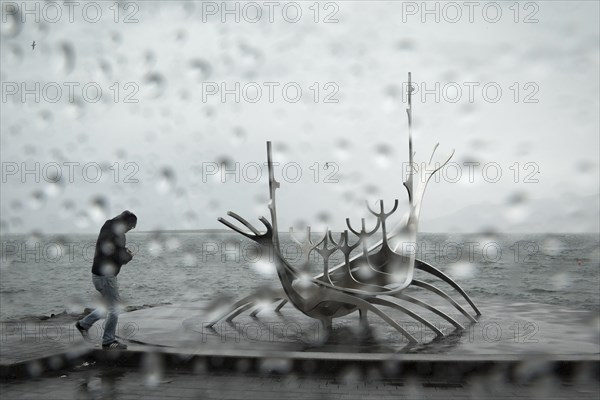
left=0, top=302, right=600, bottom=382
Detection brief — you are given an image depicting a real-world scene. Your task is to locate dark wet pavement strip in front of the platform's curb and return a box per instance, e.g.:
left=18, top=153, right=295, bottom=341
left=0, top=362, right=599, bottom=400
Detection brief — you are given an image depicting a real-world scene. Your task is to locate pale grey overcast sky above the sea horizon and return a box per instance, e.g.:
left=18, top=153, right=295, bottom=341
left=0, top=1, right=600, bottom=233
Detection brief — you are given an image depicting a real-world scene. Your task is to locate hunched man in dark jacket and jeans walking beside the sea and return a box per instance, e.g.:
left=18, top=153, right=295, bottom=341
left=75, top=210, right=137, bottom=350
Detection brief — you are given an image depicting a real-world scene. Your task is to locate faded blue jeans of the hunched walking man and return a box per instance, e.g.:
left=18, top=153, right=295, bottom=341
left=79, top=274, right=121, bottom=344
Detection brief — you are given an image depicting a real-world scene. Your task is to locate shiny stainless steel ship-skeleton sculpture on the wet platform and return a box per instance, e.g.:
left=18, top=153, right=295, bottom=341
left=208, top=73, right=481, bottom=343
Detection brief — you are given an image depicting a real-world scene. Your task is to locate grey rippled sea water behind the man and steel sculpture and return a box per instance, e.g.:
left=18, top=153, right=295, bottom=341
left=0, top=232, right=600, bottom=320
